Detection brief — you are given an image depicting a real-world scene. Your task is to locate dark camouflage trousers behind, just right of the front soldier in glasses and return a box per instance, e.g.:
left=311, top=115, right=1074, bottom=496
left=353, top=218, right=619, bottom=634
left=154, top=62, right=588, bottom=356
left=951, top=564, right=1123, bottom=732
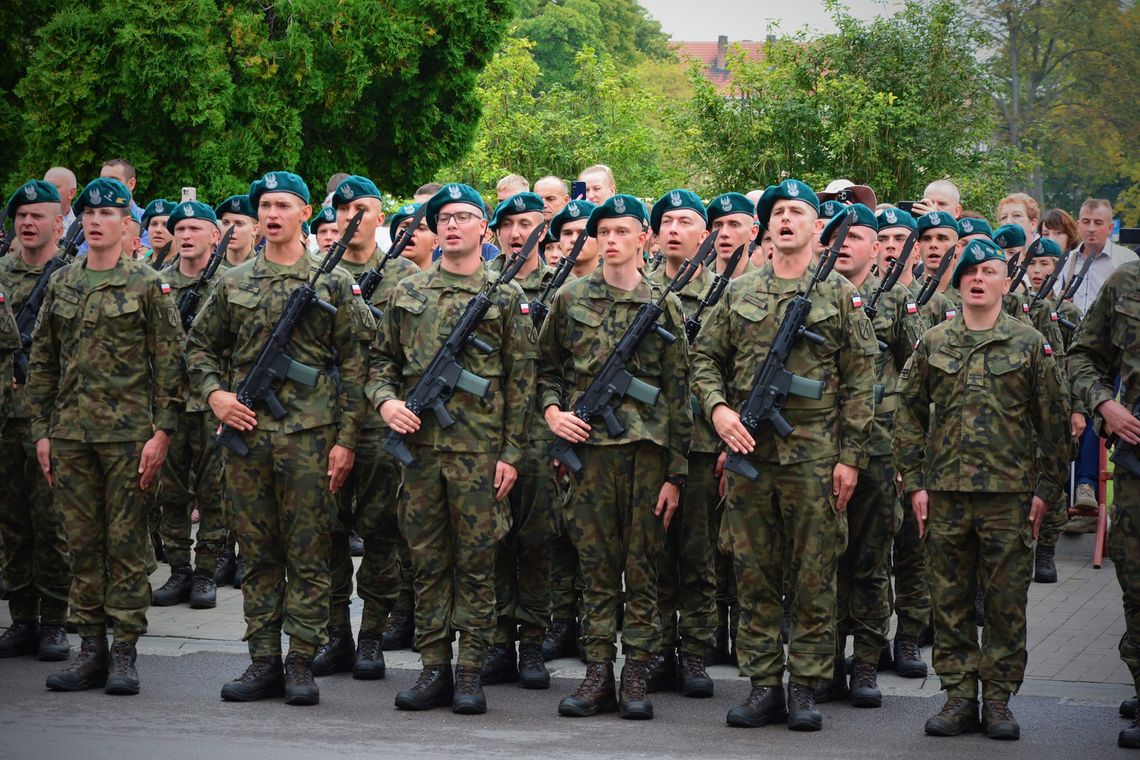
left=495, top=441, right=557, bottom=644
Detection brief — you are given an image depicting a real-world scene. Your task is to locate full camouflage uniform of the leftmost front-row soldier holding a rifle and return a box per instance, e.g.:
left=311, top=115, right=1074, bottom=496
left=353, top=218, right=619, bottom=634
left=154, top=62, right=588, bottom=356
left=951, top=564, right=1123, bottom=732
left=187, top=255, right=374, bottom=657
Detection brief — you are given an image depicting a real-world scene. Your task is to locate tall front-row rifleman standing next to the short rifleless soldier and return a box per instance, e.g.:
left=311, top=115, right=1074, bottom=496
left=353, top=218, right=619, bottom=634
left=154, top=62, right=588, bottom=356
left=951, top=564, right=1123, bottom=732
left=693, top=179, right=879, bottom=730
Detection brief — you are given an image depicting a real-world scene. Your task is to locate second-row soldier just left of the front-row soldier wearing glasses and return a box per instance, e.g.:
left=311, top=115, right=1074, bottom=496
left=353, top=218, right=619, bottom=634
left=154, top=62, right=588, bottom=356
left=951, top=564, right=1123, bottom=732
left=312, top=174, right=416, bottom=680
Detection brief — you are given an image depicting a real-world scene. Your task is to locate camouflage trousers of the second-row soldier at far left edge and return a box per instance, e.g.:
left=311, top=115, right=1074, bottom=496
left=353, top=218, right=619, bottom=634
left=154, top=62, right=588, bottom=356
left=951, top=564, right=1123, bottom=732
left=0, top=419, right=71, bottom=626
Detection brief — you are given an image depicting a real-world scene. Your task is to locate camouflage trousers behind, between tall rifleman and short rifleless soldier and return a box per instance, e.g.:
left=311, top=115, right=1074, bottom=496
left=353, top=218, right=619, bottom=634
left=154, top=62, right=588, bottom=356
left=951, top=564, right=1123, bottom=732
left=836, top=456, right=903, bottom=663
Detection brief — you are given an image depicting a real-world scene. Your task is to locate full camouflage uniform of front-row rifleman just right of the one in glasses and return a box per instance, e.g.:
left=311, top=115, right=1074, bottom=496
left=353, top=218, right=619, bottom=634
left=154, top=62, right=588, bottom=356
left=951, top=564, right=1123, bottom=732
left=538, top=269, right=693, bottom=663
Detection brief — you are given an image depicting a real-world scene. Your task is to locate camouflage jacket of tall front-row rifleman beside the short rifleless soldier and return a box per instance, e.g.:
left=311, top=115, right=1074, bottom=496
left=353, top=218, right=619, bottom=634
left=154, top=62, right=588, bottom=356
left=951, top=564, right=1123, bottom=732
left=693, top=261, right=879, bottom=468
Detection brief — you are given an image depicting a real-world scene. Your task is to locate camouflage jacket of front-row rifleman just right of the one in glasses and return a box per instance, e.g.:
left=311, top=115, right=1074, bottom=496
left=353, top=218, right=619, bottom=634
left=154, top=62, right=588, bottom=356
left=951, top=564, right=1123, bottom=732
left=538, top=264, right=693, bottom=475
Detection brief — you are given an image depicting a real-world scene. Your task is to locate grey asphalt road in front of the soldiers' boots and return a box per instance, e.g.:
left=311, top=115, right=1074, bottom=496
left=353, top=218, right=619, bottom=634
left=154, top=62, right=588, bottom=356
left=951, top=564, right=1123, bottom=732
left=0, top=653, right=1140, bottom=760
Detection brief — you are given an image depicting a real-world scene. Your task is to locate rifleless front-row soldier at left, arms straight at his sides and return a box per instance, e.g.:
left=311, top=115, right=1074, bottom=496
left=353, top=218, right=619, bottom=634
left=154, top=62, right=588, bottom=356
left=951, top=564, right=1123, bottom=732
left=27, top=179, right=186, bottom=694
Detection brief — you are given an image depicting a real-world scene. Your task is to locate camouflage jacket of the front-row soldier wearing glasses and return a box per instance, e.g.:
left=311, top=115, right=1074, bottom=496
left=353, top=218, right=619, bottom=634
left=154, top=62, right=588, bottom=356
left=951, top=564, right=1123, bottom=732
left=366, top=261, right=537, bottom=467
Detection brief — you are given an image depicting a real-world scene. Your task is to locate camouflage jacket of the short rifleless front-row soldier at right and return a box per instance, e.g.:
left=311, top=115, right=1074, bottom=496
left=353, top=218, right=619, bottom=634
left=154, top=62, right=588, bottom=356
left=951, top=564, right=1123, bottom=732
left=894, top=312, right=1069, bottom=504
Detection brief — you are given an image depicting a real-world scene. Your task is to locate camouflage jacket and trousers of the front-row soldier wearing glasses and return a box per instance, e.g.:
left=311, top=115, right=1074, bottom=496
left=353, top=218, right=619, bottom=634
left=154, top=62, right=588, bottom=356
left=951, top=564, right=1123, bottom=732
left=366, top=262, right=535, bottom=669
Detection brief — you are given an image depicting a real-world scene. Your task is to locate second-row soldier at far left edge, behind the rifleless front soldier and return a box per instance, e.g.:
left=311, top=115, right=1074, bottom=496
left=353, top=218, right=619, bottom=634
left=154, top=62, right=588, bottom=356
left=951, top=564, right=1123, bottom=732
left=0, top=180, right=71, bottom=661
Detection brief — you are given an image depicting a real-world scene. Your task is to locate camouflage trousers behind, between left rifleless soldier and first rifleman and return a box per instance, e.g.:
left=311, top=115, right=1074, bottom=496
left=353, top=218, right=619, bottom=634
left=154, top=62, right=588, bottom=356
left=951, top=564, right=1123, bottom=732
left=155, top=411, right=228, bottom=575
